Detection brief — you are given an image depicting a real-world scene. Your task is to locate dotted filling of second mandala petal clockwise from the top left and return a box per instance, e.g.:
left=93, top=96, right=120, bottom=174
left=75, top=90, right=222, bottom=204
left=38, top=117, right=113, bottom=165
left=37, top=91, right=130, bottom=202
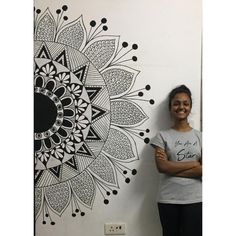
left=57, top=22, right=85, bottom=49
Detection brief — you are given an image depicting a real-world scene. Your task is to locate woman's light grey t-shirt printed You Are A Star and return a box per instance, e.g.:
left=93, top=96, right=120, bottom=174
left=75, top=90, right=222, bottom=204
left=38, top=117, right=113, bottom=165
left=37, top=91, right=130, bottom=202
left=152, top=129, right=202, bottom=204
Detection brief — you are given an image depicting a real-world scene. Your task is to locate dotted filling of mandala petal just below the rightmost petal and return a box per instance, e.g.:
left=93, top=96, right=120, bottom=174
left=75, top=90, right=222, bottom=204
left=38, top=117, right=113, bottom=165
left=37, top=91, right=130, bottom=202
left=103, top=129, right=134, bottom=160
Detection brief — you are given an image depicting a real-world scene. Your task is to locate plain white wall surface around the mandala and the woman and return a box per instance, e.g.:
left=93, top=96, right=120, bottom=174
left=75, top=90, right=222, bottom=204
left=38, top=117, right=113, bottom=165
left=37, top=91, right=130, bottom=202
left=35, top=0, right=201, bottom=236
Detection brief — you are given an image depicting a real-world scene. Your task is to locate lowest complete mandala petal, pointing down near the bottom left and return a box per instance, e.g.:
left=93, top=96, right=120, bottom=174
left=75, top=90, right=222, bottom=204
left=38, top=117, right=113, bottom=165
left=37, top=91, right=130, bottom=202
left=45, top=182, right=71, bottom=215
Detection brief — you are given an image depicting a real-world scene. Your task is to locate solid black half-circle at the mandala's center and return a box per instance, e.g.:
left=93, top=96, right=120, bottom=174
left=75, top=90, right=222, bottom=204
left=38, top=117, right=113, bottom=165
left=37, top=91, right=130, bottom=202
left=34, top=93, right=57, bottom=133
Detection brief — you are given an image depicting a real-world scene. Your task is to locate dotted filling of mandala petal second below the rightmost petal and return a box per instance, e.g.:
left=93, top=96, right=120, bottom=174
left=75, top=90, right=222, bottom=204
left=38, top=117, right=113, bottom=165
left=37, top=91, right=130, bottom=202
left=89, top=155, right=115, bottom=184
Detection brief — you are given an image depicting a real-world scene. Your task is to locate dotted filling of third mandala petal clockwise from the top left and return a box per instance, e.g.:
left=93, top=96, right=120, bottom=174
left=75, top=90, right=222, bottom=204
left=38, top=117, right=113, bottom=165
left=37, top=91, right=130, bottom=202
left=85, top=39, right=116, bottom=69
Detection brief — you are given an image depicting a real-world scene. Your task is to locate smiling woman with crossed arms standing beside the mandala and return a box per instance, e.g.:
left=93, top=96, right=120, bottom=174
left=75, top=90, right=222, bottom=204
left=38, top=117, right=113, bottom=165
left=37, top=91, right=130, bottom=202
left=152, top=85, right=202, bottom=236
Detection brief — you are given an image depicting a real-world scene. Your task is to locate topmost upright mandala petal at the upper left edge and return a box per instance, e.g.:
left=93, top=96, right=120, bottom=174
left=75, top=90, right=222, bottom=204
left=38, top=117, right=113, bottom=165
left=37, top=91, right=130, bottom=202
left=35, top=8, right=56, bottom=41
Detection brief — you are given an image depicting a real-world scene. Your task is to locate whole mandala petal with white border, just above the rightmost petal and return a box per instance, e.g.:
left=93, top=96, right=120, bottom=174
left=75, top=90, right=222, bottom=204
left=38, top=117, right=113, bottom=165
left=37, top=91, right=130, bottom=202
left=102, top=65, right=139, bottom=98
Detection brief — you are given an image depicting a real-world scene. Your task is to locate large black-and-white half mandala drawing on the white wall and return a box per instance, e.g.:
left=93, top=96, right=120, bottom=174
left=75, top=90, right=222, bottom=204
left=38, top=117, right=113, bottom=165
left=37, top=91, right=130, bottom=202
left=34, top=5, right=154, bottom=225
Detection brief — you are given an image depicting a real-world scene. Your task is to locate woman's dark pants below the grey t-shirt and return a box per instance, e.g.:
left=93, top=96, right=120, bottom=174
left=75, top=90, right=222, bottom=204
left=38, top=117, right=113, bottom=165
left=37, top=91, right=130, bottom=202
left=158, top=202, right=202, bottom=236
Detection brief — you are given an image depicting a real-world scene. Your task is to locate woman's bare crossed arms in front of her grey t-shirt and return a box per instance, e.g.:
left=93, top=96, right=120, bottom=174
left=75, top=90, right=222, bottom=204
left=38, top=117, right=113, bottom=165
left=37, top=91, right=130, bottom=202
left=155, top=147, right=202, bottom=178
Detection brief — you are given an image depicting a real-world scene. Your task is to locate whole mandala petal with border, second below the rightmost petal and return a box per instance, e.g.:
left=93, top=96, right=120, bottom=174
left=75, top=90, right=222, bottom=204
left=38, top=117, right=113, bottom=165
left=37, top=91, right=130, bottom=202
left=88, top=154, right=118, bottom=187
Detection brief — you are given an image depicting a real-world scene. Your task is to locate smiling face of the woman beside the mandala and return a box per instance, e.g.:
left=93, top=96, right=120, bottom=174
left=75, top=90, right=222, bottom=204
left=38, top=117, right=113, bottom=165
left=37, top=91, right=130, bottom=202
left=170, top=93, right=192, bottom=120
